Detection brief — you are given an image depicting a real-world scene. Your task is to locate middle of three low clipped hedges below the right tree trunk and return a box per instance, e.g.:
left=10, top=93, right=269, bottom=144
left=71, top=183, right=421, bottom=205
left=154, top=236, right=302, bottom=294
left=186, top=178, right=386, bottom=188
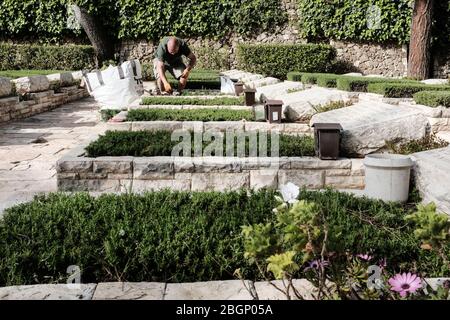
left=368, top=82, right=450, bottom=98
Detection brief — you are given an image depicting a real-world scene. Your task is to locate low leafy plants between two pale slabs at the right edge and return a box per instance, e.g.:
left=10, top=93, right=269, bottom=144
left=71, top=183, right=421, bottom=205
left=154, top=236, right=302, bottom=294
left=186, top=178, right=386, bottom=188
left=386, top=134, right=449, bottom=155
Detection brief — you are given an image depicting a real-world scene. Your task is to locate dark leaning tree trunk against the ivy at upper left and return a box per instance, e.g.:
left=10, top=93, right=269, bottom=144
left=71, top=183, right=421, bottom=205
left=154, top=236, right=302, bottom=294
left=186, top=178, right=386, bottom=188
left=71, top=4, right=114, bottom=68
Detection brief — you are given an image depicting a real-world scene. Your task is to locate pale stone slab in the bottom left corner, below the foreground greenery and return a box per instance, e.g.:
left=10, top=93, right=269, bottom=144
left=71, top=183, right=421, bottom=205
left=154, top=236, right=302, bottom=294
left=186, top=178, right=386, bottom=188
left=0, top=284, right=96, bottom=300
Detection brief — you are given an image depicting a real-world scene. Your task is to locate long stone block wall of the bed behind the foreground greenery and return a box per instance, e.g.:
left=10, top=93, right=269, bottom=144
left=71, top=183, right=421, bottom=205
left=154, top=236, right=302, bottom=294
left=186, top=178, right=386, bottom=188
left=56, top=137, right=364, bottom=192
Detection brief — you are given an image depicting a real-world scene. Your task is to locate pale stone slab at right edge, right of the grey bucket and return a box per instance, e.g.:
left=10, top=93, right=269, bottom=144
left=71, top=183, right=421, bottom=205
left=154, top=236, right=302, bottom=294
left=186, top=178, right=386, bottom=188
left=412, top=147, right=450, bottom=215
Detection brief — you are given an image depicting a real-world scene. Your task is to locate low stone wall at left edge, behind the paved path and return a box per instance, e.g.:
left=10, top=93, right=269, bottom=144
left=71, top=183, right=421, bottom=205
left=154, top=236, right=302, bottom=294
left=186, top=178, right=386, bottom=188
left=0, top=73, right=89, bottom=123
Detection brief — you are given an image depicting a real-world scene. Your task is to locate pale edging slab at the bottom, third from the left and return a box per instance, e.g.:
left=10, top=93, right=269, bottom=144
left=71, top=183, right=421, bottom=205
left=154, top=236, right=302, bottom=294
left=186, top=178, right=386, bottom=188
left=164, top=280, right=252, bottom=300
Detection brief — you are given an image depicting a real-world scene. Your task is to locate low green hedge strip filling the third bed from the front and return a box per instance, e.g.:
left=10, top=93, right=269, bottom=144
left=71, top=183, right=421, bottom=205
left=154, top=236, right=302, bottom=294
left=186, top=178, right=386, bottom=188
left=127, top=109, right=254, bottom=121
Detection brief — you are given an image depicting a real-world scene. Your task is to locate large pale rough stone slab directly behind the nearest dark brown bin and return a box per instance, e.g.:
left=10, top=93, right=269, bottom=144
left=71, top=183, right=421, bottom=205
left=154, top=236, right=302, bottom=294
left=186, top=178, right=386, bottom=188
left=310, top=102, right=429, bottom=156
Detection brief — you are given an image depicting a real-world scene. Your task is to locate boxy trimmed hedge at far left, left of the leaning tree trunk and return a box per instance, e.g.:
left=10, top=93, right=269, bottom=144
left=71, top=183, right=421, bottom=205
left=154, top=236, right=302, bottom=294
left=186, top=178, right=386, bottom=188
left=0, top=43, right=95, bottom=71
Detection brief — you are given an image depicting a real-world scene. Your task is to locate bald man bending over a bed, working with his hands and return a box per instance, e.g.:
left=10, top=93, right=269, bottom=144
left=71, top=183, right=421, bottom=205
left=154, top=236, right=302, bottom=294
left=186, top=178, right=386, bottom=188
left=153, top=37, right=197, bottom=94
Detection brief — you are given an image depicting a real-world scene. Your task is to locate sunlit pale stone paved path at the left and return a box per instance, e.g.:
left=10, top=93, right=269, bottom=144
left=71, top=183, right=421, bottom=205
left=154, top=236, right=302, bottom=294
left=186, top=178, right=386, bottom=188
left=0, top=98, right=106, bottom=216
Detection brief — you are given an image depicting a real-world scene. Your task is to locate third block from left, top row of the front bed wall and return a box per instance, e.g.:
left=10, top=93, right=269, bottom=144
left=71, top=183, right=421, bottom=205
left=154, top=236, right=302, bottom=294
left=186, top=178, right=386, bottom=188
left=133, top=157, right=174, bottom=180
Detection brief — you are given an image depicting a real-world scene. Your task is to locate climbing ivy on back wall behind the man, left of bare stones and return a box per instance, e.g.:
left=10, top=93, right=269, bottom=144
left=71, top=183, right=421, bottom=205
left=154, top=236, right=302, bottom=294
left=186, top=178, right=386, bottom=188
left=0, top=0, right=287, bottom=42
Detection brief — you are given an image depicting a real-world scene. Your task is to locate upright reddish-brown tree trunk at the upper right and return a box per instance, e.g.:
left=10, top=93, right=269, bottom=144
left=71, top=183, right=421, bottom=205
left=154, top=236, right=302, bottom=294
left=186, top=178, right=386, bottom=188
left=408, top=0, right=434, bottom=80
